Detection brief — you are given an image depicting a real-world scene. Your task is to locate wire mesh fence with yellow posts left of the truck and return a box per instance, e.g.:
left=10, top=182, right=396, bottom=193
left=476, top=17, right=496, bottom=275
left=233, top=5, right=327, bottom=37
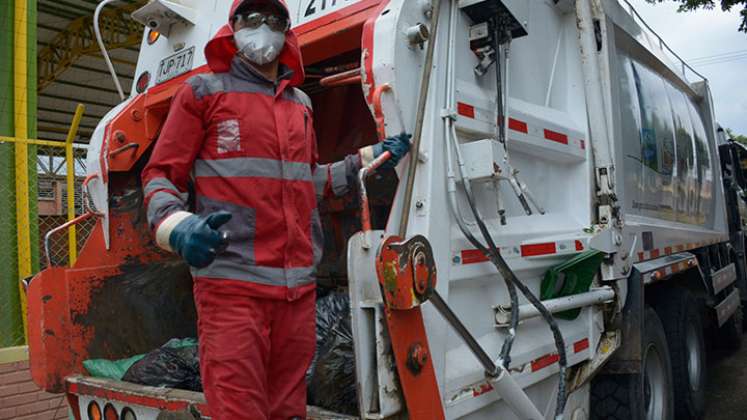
left=0, top=137, right=95, bottom=348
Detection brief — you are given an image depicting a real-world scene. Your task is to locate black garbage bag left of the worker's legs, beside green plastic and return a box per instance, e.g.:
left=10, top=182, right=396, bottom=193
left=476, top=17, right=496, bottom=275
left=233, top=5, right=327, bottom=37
left=122, top=340, right=202, bottom=392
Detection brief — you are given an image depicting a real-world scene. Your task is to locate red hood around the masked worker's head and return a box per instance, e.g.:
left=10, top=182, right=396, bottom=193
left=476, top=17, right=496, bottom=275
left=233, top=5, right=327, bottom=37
left=205, top=0, right=305, bottom=86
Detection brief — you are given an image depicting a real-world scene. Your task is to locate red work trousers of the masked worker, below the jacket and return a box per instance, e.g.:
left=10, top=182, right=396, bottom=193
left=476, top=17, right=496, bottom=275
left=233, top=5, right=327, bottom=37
left=194, top=280, right=316, bottom=420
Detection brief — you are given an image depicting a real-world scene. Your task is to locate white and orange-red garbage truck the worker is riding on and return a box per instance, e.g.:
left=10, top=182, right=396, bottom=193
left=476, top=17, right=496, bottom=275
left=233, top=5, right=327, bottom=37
left=26, top=0, right=747, bottom=420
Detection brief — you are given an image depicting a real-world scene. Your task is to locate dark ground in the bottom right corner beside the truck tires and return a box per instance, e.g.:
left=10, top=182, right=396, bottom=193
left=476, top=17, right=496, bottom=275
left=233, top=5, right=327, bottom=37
left=705, top=342, right=747, bottom=420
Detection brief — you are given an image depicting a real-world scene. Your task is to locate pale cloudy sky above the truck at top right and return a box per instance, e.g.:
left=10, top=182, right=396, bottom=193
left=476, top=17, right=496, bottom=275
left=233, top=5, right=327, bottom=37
left=629, top=0, right=747, bottom=135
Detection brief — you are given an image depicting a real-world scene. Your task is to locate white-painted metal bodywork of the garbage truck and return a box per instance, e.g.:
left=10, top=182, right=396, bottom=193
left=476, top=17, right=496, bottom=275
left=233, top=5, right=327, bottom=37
left=74, top=0, right=728, bottom=419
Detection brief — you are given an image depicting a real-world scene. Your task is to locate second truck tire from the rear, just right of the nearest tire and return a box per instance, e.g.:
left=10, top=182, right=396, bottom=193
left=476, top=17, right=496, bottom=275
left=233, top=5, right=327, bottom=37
left=655, top=287, right=707, bottom=420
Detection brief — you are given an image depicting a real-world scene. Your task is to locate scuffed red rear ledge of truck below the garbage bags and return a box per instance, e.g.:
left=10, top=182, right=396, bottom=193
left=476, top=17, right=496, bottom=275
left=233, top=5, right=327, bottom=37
left=66, top=376, right=358, bottom=420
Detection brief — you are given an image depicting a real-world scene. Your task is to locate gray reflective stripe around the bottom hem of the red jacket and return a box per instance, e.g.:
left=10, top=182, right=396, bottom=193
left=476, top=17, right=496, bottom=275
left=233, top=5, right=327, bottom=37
left=192, top=256, right=316, bottom=288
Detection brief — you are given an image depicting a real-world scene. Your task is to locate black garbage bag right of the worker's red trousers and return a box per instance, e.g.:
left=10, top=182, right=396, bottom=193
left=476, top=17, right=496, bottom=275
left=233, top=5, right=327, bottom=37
left=308, top=292, right=359, bottom=415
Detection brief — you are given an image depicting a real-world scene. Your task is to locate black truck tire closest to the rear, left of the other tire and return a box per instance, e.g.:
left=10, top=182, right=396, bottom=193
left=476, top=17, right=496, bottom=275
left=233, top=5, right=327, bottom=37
left=591, top=307, right=674, bottom=420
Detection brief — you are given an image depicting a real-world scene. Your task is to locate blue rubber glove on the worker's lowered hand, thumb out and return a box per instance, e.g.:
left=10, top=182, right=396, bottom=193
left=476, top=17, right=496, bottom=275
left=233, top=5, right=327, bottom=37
left=169, top=211, right=232, bottom=268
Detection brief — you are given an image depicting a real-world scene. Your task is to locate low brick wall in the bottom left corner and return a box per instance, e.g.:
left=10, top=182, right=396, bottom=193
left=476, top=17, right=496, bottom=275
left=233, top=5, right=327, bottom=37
left=0, top=360, right=68, bottom=420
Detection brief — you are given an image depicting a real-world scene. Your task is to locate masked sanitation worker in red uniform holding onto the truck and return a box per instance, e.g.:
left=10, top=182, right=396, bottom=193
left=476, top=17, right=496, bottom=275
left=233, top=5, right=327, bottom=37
left=143, top=0, right=410, bottom=420
